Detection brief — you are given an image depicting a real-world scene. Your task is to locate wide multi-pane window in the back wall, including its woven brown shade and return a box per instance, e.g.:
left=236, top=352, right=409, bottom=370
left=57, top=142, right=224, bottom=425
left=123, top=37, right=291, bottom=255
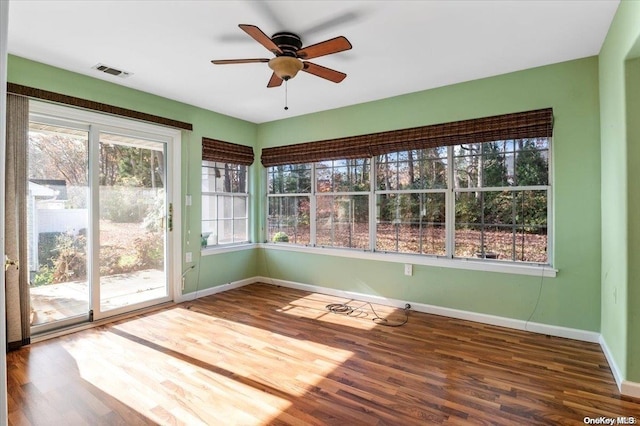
left=262, top=108, right=553, bottom=264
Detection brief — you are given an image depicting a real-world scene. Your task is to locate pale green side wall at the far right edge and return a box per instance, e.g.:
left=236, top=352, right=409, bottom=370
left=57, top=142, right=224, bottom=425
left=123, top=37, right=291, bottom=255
left=599, top=1, right=640, bottom=382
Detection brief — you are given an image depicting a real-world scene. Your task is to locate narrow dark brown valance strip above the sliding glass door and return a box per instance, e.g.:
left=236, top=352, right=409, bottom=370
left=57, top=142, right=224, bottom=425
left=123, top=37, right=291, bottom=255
left=7, top=83, right=193, bottom=131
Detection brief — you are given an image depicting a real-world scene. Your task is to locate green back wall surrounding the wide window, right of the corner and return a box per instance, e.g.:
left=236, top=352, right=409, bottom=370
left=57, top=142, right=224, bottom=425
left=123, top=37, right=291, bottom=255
left=258, top=57, right=601, bottom=331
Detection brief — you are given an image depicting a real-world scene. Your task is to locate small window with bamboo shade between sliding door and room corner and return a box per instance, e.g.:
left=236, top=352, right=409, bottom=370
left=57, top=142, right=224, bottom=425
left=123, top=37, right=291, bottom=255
left=201, top=138, right=253, bottom=248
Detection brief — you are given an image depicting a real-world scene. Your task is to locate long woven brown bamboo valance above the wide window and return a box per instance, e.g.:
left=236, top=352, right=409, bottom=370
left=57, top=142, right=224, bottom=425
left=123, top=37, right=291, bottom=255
left=262, top=108, right=553, bottom=167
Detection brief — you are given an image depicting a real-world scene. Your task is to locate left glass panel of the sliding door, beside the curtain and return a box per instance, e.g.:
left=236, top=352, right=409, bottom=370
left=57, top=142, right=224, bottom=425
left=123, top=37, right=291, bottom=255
left=26, top=121, right=90, bottom=327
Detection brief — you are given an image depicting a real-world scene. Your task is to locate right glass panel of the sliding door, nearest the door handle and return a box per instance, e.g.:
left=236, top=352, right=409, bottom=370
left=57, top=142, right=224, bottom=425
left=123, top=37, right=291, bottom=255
left=98, top=133, right=169, bottom=312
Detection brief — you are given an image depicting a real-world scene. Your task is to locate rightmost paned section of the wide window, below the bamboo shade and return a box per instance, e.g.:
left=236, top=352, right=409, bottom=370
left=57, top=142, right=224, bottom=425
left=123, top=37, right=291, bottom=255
left=453, top=138, right=551, bottom=263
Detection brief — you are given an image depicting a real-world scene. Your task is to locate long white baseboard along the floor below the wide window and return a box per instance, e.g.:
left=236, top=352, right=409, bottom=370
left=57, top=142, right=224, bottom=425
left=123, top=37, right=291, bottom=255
left=256, top=277, right=600, bottom=343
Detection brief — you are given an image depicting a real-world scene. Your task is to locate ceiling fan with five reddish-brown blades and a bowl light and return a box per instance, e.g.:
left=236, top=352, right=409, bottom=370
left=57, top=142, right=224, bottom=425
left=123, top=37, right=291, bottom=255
left=211, top=24, right=352, bottom=87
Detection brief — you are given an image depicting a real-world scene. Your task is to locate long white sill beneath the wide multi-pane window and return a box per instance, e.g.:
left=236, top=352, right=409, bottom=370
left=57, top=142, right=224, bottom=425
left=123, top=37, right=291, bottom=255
left=254, top=243, right=558, bottom=278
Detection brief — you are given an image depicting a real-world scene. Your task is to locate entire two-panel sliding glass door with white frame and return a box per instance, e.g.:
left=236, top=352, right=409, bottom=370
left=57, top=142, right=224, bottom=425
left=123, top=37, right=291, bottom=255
left=27, top=102, right=179, bottom=333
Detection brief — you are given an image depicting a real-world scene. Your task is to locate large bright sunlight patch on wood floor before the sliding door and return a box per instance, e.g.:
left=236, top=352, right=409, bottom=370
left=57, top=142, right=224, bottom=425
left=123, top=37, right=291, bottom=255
left=63, top=308, right=353, bottom=425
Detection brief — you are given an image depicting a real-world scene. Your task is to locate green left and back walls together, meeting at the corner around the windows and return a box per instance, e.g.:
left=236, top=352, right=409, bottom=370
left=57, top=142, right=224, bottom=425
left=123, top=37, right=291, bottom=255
left=9, top=53, right=601, bottom=331
